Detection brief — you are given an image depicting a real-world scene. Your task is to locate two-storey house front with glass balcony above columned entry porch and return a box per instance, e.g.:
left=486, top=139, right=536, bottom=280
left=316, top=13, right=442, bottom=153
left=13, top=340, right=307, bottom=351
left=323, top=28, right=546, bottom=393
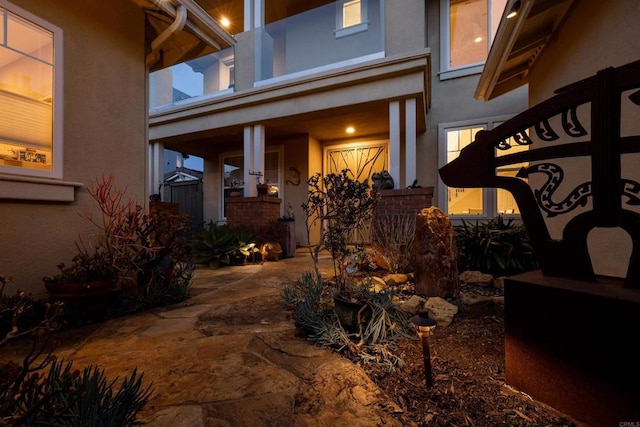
left=149, top=0, right=527, bottom=245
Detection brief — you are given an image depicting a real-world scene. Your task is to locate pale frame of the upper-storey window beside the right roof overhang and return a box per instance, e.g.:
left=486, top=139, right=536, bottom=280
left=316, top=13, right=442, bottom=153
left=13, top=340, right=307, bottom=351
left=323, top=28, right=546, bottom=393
left=439, top=0, right=504, bottom=80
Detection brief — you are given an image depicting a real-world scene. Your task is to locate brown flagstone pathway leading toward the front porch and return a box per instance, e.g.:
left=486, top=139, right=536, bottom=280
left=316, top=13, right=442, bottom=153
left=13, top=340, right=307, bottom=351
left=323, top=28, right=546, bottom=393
left=11, top=251, right=400, bottom=427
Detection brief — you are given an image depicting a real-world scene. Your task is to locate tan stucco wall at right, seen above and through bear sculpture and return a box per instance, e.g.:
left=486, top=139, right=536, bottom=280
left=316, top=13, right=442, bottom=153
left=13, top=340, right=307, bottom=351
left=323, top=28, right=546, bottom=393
left=529, top=0, right=640, bottom=277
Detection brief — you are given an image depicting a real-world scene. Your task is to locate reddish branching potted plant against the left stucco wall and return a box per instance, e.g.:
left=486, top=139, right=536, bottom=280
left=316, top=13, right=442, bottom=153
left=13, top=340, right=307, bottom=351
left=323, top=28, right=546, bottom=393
left=44, top=176, right=189, bottom=320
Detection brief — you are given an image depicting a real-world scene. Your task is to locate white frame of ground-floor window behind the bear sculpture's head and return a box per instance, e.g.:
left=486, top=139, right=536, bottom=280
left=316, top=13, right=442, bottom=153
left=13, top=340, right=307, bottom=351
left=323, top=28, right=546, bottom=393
left=438, top=115, right=520, bottom=220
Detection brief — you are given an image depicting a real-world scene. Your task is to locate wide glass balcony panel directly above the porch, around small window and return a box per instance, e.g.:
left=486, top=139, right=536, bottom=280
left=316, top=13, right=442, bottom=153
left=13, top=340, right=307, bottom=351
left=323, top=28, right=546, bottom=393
left=255, top=0, right=384, bottom=86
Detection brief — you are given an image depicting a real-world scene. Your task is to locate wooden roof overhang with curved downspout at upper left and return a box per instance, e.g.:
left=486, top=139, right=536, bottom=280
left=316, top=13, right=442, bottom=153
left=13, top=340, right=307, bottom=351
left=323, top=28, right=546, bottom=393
left=132, top=0, right=236, bottom=72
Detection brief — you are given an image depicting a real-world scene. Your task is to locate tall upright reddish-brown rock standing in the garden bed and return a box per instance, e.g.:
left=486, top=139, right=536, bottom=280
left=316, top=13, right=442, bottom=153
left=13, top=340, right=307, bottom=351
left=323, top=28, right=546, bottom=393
left=411, top=206, right=460, bottom=298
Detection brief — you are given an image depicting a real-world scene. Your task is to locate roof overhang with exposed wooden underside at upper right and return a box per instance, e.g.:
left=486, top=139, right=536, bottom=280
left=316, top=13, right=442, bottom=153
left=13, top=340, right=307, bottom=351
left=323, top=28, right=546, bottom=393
left=474, top=0, right=577, bottom=101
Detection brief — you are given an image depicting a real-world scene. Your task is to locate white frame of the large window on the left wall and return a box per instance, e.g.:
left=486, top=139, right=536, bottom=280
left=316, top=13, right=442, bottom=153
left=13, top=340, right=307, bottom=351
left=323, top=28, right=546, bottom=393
left=0, top=0, right=64, bottom=181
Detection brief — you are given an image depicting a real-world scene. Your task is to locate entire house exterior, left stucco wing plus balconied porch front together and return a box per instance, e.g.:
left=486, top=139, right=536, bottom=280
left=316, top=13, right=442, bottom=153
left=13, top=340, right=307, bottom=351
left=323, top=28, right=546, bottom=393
left=0, top=0, right=527, bottom=294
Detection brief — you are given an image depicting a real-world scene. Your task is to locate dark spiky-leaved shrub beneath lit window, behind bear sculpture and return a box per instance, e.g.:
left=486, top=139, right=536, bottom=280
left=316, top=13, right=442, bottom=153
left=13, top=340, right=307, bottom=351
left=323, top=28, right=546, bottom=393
left=454, top=216, right=538, bottom=276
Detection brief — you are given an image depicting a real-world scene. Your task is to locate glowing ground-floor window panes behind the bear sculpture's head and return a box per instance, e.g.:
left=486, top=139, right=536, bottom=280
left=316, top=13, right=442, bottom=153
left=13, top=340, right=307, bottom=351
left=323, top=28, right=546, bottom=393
left=439, top=117, right=529, bottom=218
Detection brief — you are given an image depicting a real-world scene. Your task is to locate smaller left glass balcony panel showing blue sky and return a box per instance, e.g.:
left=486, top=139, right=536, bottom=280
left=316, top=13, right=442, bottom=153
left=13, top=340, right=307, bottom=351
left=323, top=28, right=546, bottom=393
left=149, top=48, right=235, bottom=109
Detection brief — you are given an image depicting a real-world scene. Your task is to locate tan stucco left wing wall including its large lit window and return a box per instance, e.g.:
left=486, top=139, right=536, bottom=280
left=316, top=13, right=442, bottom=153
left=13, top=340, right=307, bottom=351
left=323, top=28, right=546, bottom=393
left=0, top=0, right=233, bottom=296
